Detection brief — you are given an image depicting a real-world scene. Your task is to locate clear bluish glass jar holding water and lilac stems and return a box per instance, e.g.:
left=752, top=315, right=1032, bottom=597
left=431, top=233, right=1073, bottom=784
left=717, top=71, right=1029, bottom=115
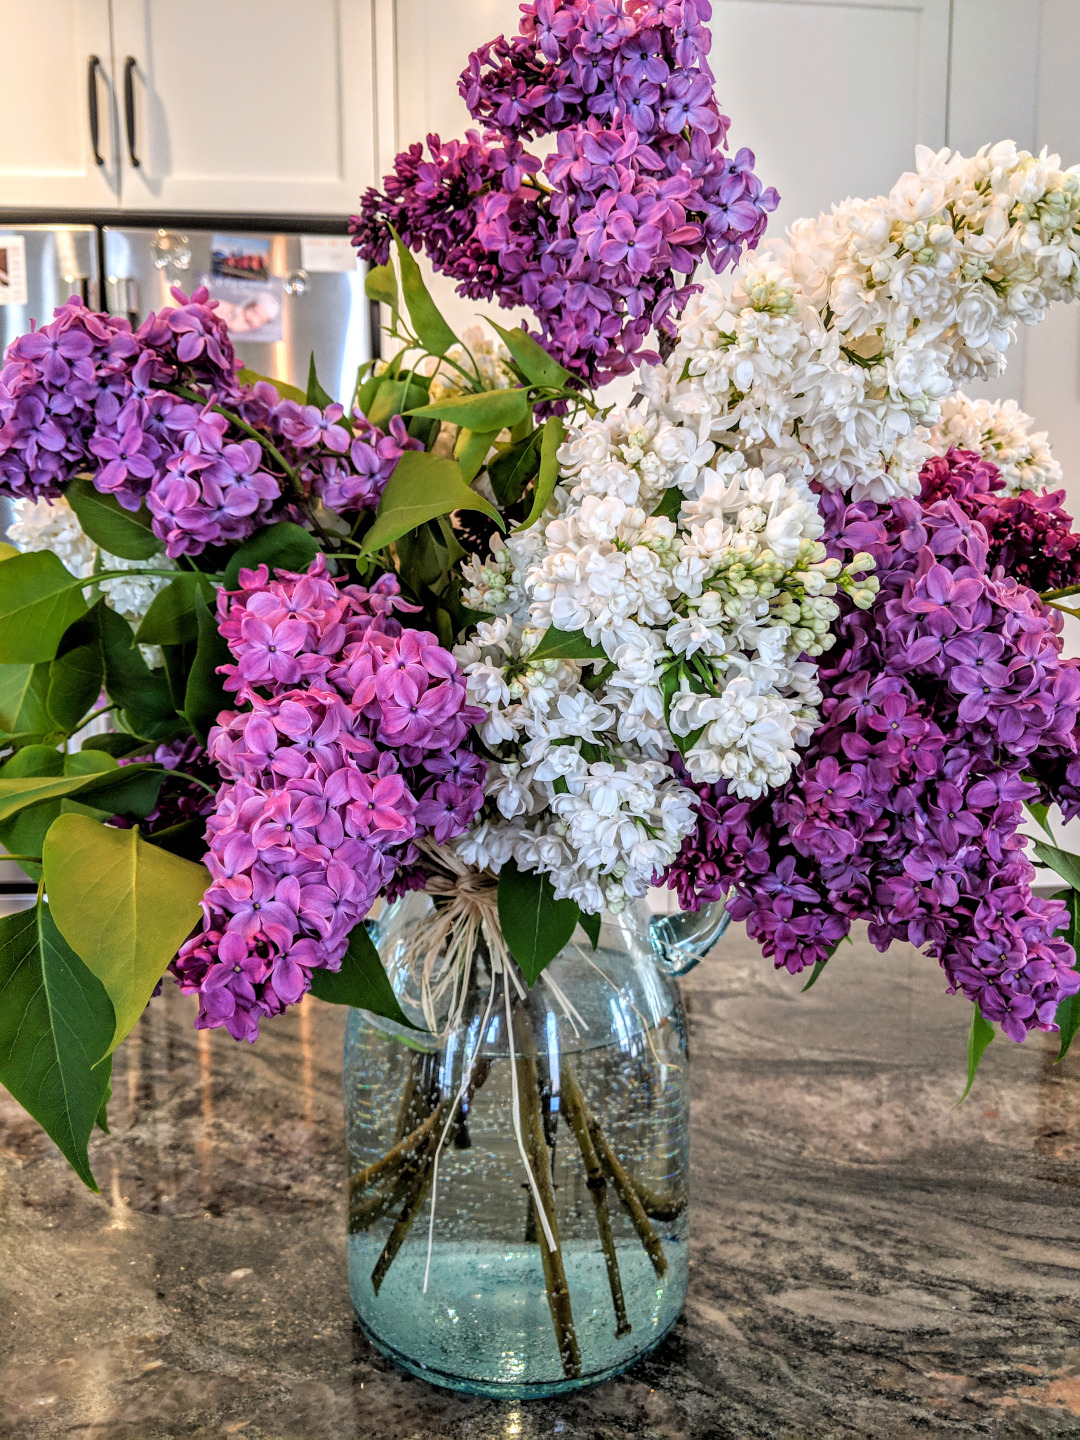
left=344, top=893, right=727, bottom=1398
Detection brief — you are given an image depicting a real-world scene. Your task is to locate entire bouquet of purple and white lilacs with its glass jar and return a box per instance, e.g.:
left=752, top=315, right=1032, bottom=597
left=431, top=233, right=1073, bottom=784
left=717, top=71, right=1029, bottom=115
left=0, top=0, right=1080, bottom=1395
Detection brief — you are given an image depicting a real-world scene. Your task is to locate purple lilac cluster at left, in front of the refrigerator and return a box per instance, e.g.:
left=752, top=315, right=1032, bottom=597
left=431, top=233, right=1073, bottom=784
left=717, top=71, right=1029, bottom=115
left=0, top=288, right=416, bottom=557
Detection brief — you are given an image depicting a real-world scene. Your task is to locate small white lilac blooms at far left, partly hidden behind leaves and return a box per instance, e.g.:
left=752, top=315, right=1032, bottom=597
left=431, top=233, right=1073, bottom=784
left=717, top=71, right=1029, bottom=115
left=7, top=497, right=176, bottom=665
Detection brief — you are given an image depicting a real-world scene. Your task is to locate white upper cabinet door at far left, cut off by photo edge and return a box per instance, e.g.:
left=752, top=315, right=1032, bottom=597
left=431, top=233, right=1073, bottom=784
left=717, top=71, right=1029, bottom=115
left=0, top=0, right=117, bottom=210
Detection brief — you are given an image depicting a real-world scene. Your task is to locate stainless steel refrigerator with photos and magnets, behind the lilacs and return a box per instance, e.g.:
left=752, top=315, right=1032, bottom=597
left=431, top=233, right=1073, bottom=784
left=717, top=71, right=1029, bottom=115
left=0, top=219, right=372, bottom=403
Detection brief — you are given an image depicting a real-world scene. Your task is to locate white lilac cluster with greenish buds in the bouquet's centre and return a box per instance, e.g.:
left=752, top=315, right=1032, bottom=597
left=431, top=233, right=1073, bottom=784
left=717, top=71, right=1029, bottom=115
left=456, top=405, right=876, bottom=912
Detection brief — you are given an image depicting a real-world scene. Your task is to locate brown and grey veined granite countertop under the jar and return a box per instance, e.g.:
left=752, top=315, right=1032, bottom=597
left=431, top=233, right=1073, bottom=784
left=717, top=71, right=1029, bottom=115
left=0, top=926, right=1080, bottom=1440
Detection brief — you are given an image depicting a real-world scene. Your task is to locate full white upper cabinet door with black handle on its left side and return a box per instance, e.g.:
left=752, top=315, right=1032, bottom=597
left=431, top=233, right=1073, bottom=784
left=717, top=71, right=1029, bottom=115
left=112, top=0, right=374, bottom=215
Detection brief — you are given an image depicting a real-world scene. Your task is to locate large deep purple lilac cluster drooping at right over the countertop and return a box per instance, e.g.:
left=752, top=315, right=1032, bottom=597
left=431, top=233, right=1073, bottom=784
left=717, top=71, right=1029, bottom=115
left=667, top=466, right=1080, bottom=1040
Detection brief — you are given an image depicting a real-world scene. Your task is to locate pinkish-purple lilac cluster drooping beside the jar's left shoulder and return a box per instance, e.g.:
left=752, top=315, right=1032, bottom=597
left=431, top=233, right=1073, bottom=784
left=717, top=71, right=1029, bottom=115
left=173, top=556, right=487, bottom=1040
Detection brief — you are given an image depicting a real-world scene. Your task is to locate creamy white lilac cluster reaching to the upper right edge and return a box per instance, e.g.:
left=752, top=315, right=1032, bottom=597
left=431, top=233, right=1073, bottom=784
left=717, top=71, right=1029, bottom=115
left=642, top=141, right=1080, bottom=501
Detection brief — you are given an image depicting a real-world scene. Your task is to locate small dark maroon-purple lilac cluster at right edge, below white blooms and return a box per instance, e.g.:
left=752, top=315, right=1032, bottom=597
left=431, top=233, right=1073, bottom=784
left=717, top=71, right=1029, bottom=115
left=920, top=449, right=1080, bottom=592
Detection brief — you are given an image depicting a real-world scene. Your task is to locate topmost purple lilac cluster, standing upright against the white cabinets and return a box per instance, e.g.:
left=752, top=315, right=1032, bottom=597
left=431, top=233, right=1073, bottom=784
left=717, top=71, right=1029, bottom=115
left=353, top=0, right=778, bottom=382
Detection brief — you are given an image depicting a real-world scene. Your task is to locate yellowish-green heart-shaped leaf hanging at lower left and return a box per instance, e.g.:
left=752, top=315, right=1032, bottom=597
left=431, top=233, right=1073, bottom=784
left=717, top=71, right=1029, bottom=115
left=42, top=815, right=209, bottom=1058
